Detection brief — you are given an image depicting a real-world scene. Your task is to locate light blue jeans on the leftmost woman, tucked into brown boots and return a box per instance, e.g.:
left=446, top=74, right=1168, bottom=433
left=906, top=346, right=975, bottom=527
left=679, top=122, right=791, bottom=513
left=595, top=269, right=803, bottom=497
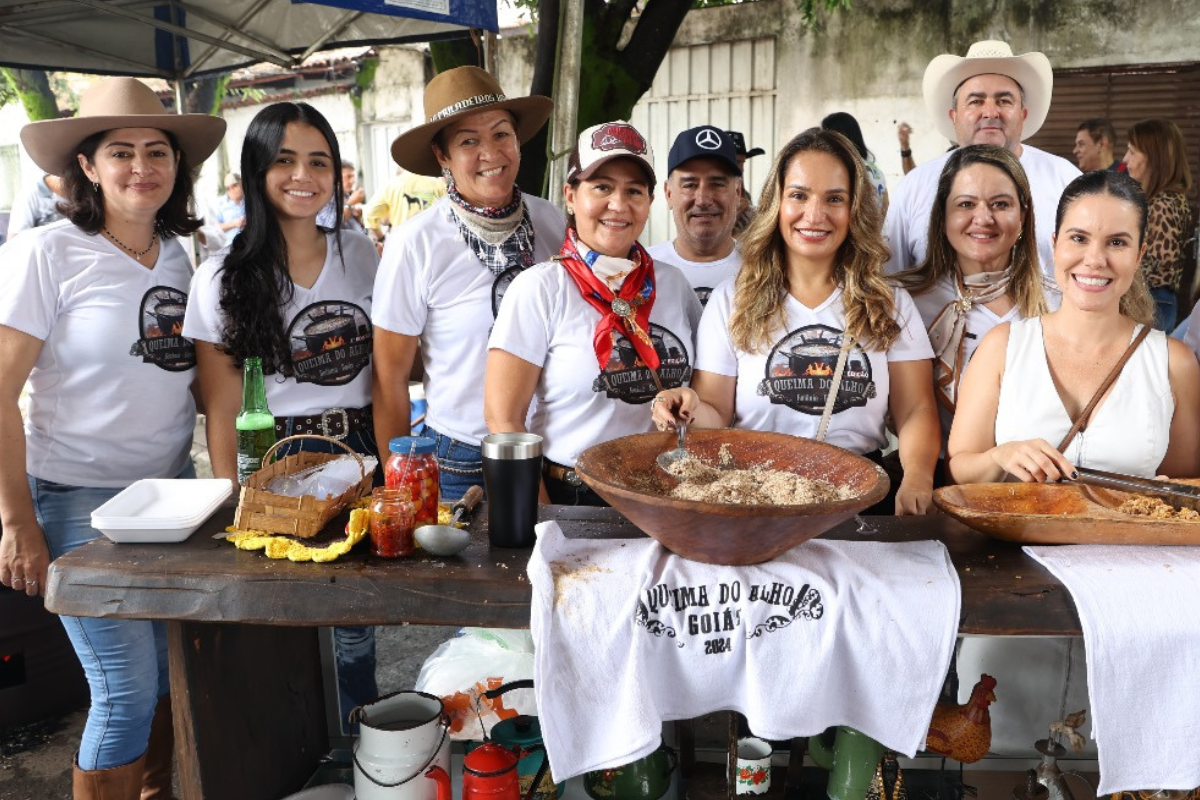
left=26, top=462, right=196, bottom=770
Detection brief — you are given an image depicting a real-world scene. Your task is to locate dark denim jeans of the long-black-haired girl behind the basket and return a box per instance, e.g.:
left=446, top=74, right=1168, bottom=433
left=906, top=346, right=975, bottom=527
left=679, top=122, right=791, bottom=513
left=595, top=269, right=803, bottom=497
left=278, top=428, right=383, bottom=735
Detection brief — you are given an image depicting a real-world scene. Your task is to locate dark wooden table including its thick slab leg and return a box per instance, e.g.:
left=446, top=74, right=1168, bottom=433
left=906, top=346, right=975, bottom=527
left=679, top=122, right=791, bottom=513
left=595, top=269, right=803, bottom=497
left=46, top=506, right=1081, bottom=800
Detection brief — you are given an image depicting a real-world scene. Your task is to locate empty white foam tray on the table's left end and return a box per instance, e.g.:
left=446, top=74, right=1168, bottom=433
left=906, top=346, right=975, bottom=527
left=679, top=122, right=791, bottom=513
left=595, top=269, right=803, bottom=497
left=91, top=479, right=233, bottom=543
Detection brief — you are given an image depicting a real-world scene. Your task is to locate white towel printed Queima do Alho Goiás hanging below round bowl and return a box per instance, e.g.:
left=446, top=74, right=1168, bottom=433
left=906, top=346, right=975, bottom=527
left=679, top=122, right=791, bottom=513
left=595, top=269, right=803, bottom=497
left=529, top=522, right=960, bottom=781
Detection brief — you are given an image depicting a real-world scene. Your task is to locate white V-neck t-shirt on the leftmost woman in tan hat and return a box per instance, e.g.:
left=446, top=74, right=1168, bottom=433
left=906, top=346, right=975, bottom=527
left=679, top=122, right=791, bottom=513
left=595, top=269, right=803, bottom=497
left=0, top=219, right=196, bottom=488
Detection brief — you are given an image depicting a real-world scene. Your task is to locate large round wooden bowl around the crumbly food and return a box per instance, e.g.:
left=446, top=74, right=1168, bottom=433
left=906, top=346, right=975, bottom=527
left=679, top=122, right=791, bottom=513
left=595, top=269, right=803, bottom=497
left=575, top=429, right=888, bottom=565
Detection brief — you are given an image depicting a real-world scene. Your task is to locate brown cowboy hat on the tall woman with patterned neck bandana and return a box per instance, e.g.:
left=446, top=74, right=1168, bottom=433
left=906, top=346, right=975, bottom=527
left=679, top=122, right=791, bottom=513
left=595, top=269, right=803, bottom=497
left=391, top=67, right=554, bottom=176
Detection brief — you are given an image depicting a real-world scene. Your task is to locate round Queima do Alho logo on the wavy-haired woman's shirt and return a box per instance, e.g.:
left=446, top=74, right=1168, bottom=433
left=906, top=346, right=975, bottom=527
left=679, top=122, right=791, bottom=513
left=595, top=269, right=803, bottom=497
left=758, top=325, right=876, bottom=416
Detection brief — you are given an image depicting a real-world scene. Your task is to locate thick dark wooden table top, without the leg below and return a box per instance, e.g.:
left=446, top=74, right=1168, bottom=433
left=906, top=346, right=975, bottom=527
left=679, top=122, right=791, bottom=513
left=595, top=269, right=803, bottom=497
left=46, top=506, right=1080, bottom=636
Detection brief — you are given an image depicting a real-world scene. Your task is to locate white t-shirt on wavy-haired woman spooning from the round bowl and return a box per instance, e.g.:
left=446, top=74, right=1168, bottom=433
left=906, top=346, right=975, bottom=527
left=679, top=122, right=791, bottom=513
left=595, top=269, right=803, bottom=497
left=696, top=282, right=934, bottom=453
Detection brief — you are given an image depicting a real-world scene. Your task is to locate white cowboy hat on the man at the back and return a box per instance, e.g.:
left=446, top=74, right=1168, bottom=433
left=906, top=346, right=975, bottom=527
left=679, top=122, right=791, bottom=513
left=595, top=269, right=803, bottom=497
left=923, top=41, right=1054, bottom=142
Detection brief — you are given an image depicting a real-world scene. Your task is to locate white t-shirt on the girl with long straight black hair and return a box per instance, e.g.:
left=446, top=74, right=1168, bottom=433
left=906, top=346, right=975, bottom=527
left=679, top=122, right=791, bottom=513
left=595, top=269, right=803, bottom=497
left=184, top=230, right=376, bottom=416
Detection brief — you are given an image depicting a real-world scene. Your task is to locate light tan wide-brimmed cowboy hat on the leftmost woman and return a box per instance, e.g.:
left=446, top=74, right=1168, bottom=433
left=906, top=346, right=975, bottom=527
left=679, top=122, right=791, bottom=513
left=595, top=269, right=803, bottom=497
left=20, top=78, right=224, bottom=175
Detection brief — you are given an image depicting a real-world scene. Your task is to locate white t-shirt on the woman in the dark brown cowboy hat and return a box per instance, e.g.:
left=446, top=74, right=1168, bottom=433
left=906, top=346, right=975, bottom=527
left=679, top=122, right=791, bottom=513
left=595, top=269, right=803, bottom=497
left=372, top=194, right=566, bottom=445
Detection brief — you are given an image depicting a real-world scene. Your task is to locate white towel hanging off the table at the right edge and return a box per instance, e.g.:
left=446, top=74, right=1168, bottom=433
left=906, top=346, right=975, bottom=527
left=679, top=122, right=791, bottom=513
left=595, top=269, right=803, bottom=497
left=1025, top=545, right=1200, bottom=795
